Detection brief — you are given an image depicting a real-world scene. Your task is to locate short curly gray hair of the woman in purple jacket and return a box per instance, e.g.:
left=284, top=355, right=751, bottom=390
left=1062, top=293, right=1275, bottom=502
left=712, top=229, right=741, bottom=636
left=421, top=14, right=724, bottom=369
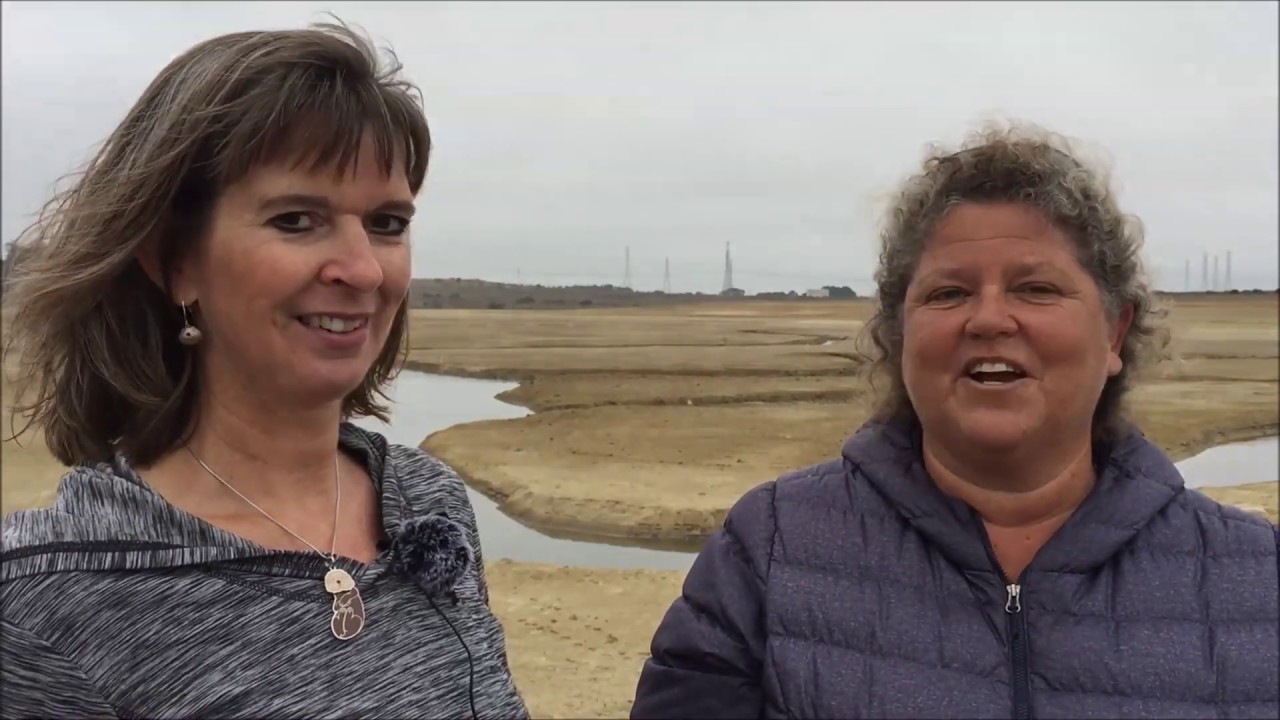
left=863, top=124, right=1169, bottom=439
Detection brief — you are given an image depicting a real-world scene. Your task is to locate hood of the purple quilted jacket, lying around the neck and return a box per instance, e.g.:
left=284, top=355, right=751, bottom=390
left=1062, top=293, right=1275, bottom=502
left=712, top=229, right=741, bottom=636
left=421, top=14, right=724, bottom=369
left=842, top=421, right=1185, bottom=573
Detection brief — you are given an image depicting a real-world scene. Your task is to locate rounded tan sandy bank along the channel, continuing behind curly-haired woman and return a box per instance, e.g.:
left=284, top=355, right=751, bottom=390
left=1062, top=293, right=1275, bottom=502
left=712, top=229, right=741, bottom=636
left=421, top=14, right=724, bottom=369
left=424, top=380, right=1280, bottom=543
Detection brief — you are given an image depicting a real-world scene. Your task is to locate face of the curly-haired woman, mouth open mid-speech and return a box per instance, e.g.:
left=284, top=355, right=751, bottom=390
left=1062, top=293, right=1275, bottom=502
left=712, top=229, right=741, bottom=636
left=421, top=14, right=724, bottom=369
left=902, top=198, right=1132, bottom=451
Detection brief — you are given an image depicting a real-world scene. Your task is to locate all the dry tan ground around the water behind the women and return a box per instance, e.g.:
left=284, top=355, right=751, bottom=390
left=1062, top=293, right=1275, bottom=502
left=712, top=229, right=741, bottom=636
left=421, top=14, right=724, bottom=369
left=3, top=296, right=1280, bottom=717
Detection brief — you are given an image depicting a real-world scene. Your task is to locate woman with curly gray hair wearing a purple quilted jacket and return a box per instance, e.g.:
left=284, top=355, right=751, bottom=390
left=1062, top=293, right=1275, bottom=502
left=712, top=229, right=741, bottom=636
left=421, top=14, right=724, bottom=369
left=632, top=128, right=1280, bottom=717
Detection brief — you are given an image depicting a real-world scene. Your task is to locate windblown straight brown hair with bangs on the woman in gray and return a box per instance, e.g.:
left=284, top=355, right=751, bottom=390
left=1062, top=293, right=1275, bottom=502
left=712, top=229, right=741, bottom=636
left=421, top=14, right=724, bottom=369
left=4, top=23, right=431, bottom=466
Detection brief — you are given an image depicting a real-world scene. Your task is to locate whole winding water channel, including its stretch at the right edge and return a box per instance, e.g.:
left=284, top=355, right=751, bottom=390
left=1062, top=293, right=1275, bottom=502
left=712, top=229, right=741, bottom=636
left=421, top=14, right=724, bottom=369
left=357, top=370, right=1280, bottom=570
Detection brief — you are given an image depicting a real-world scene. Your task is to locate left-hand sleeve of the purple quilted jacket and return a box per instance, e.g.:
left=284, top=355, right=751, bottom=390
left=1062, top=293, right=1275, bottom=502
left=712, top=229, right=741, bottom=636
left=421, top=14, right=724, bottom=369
left=631, top=483, right=774, bottom=719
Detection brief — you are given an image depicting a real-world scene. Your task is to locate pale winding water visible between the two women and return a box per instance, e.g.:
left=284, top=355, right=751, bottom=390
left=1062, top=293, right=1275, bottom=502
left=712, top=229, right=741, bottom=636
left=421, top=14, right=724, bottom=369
left=356, top=370, right=694, bottom=570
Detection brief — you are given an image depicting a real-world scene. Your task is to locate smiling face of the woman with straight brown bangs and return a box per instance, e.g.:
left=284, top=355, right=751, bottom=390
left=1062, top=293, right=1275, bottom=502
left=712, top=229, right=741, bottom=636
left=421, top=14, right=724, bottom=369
left=175, top=135, right=413, bottom=405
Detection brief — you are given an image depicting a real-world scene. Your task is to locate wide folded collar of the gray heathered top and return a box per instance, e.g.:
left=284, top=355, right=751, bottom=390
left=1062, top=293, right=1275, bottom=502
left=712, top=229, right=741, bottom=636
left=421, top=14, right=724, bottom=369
left=0, top=423, right=403, bottom=582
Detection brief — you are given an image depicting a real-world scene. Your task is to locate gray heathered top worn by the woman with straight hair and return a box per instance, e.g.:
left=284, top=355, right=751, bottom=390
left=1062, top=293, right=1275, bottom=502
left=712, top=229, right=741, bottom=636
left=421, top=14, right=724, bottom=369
left=0, top=425, right=527, bottom=717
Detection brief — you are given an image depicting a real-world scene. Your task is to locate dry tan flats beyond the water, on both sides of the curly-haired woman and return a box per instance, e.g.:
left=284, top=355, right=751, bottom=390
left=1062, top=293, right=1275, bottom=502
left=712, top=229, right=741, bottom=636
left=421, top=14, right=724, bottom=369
left=422, top=296, right=1280, bottom=539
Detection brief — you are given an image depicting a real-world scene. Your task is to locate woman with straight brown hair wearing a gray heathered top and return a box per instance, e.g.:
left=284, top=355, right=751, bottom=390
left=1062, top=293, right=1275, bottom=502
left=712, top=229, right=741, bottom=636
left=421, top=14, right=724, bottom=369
left=0, top=16, right=527, bottom=717
